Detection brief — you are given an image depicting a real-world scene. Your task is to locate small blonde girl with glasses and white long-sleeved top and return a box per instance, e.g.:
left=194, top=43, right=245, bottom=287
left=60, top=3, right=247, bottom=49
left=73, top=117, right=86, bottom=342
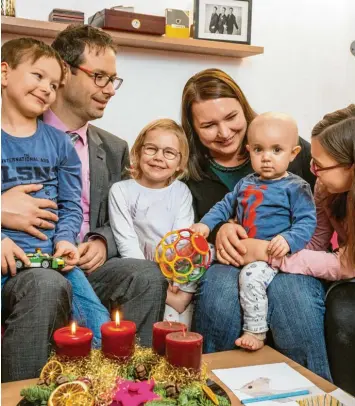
left=109, top=119, right=195, bottom=321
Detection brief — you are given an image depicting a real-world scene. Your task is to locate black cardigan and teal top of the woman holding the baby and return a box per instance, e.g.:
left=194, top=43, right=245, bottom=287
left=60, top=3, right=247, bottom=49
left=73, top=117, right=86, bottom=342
left=187, top=138, right=316, bottom=241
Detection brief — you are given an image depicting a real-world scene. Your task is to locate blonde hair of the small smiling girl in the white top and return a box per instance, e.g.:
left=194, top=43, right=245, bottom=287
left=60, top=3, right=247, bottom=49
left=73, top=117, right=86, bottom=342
left=129, top=118, right=189, bottom=183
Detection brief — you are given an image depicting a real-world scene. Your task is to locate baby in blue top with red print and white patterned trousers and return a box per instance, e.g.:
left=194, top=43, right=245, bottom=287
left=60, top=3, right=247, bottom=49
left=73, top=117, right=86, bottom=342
left=192, top=113, right=316, bottom=350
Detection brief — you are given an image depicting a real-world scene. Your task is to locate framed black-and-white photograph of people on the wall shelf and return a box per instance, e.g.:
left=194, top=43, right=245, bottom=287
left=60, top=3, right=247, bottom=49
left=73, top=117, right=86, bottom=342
left=194, top=0, right=252, bottom=44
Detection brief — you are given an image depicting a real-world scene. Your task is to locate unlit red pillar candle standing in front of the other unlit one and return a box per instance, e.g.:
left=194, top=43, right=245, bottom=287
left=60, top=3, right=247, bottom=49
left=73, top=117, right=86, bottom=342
left=166, top=332, right=203, bottom=371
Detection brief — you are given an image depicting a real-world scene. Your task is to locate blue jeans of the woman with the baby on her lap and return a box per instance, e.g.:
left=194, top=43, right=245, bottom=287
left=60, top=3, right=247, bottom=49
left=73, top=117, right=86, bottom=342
left=193, top=264, right=332, bottom=381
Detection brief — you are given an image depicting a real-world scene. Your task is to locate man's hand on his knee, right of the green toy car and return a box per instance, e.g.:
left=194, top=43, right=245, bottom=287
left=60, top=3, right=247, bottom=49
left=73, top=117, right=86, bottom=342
left=78, top=238, right=107, bottom=274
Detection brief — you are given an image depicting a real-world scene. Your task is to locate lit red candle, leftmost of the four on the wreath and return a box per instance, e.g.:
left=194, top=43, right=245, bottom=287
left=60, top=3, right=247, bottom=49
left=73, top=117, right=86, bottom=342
left=53, top=323, right=93, bottom=357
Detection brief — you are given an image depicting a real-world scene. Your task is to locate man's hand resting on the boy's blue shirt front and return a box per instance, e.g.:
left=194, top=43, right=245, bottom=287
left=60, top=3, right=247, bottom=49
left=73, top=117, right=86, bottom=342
left=1, top=185, right=58, bottom=240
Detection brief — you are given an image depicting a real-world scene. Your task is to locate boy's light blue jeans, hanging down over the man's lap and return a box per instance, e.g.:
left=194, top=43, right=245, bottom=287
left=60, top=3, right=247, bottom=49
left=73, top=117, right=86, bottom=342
left=1, top=267, right=110, bottom=348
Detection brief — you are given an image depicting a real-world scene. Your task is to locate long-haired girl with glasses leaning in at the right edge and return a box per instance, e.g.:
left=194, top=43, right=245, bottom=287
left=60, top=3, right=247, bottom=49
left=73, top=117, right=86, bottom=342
left=248, top=104, right=355, bottom=395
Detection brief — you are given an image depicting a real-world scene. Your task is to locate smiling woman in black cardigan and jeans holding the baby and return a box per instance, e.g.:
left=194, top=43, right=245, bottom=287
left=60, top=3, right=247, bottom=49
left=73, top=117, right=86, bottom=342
left=182, top=69, right=331, bottom=380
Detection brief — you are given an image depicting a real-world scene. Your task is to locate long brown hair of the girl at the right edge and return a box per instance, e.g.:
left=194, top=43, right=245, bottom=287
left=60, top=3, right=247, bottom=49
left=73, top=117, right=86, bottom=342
left=312, top=104, right=355, bottom=268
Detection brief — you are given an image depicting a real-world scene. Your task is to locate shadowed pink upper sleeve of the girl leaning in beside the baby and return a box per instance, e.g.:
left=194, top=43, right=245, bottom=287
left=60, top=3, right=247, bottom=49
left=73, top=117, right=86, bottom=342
left=306, top=180, right=334, bottom=251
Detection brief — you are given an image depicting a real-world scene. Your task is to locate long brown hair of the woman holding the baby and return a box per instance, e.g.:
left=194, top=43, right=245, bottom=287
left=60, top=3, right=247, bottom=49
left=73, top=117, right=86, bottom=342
left=181, top=69, right=256, bottom=180
